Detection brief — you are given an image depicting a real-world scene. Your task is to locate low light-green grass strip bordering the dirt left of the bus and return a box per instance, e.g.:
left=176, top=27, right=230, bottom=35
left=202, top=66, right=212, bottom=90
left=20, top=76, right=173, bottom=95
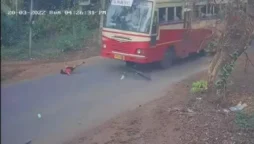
left=1, top=29, right=94, bottom=60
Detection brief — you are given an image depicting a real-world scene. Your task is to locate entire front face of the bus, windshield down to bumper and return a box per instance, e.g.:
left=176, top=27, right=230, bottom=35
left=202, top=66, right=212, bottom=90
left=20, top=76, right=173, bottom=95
left=101, top=0, right=153, bottom=63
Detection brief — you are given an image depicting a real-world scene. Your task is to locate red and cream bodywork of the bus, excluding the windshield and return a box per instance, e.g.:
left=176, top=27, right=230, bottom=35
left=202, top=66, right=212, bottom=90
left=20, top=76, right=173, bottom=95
left=101, top=0, right=215, bottom=63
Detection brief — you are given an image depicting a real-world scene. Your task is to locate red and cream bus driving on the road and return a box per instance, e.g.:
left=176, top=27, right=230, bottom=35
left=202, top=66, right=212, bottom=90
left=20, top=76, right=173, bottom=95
left=101, top=0, right=218, bottom=68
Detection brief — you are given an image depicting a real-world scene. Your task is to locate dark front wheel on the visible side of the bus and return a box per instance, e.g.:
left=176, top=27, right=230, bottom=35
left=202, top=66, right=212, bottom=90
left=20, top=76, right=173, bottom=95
left=160, top=49, right=175, bottom=69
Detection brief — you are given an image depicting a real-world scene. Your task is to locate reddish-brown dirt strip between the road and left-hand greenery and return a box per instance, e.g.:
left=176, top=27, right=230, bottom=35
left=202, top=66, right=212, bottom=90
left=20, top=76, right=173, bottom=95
left=1, top=51, right=98, bottom=84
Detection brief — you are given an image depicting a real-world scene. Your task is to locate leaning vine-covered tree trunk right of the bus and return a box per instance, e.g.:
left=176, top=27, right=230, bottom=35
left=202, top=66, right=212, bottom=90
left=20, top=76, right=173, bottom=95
left=208, top=1, right=254, bottom=96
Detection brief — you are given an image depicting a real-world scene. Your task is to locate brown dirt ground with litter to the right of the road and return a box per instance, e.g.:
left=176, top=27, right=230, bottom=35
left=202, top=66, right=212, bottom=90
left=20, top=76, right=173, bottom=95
left=64, top=54, right=254, bottom=144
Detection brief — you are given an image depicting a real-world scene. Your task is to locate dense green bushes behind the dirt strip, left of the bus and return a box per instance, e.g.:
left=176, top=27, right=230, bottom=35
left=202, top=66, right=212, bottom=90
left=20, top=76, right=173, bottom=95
left=1, top=4, right=100, bottom=60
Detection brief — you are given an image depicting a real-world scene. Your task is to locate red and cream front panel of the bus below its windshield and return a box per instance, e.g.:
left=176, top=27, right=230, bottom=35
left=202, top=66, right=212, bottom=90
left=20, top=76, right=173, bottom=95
left=101, top=30, right=150, bottom=63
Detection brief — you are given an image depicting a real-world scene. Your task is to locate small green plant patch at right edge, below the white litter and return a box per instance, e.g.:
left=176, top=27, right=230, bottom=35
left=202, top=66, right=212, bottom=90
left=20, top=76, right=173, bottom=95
left=235, top=112, right=254, bottom=129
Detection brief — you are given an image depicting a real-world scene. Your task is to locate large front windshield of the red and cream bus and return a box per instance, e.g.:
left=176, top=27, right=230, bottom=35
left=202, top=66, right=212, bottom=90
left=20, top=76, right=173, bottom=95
left=104, top=1, right=152, bottom=33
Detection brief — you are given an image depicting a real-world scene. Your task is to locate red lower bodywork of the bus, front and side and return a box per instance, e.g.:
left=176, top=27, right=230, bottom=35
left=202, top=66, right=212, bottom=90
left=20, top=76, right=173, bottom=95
left=101, top=26, right=212, bottom=63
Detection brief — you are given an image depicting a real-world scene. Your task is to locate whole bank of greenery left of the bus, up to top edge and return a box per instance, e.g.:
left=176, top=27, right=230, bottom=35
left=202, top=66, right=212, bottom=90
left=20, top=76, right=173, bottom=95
left=1, top=0, right=99, bottom=60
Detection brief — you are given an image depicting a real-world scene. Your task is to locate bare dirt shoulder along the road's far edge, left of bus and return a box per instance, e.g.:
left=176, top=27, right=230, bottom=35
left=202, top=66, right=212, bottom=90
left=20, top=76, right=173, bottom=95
left=1, top=56, right=102, bottom=85
